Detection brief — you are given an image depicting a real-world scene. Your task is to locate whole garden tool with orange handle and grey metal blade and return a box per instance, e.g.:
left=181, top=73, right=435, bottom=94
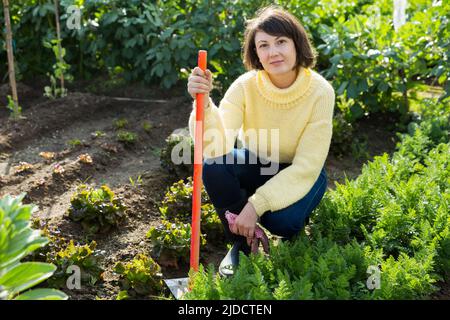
left=164, top=50, right=207, bottom=299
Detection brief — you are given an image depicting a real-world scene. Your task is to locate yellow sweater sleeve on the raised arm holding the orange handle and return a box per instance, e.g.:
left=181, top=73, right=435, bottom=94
left=189, top=80, right=245, bottom=159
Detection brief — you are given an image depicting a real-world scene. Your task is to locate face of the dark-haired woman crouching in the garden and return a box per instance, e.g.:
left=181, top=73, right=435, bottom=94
left=255, top=31, right=297, bottom=75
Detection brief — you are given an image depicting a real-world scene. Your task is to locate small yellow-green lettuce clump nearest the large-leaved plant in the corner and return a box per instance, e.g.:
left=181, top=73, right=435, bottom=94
left=47, top=240, right=104, bottom=288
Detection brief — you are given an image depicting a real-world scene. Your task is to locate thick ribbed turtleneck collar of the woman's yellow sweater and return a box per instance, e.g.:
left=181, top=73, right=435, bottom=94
left=256, top=67, right=312, bottom=109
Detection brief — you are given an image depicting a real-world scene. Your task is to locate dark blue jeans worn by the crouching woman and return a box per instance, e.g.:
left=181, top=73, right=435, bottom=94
left=202, top=148, right=327, bottom=239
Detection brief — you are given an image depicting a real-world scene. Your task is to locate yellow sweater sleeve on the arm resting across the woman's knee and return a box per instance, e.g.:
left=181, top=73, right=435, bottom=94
left=249, top=86, right=335, bottom=217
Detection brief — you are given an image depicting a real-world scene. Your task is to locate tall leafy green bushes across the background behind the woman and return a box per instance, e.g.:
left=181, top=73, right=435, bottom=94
left=0, top=0, right=450, bottom=122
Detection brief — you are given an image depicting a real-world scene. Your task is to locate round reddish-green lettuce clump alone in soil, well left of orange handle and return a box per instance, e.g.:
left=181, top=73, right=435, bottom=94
left=67, top=185, right=126, bottom=234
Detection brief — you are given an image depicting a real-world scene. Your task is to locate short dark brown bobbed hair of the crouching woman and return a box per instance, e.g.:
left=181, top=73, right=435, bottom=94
left=243, top=6, right=316, bottom=70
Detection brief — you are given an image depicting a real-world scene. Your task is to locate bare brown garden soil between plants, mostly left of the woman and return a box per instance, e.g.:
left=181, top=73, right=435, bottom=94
left=0, top=84, right=442, bottom=299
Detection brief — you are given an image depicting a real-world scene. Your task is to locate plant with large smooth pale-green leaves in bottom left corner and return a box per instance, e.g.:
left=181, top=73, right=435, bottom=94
left=0, top=194, right=68, bottom=300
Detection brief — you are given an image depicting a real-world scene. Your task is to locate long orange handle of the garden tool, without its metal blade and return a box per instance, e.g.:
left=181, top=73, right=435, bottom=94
left=190, top=50, right=207, bottom=272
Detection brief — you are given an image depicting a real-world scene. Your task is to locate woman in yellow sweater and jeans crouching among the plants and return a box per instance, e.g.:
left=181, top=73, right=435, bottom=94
left=188, top=6, right=335, bottom=275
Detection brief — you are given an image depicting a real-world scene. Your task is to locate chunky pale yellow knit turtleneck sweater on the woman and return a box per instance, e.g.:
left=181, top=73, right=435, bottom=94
left=189, top=68, right=335, bottom=216
